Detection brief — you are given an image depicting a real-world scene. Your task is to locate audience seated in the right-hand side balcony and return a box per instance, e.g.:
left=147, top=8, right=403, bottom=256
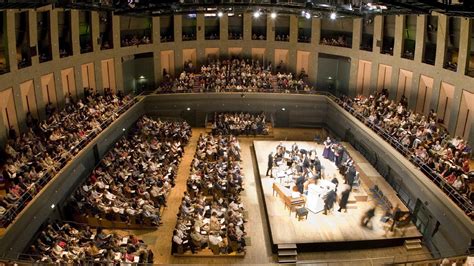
left=341, top=90, right=474, bottom=215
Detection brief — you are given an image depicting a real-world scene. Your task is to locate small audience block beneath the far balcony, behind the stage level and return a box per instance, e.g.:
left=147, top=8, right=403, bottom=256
left=212, top=112, right=268, bottom=136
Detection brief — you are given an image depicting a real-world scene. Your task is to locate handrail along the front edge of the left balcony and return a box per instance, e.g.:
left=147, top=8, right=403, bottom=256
left=0, top=97, right=138, bottom=227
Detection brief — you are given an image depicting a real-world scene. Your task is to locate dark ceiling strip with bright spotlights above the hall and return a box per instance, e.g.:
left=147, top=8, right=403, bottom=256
left=0, top=0, right=474, bottom=17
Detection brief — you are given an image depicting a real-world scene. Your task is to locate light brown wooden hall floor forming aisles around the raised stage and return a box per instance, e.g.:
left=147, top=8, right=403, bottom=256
left=86, top=128, right=431, bottom=265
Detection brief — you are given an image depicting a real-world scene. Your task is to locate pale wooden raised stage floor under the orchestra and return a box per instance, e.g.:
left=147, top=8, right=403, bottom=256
left=253, top=140, right=421, bottom=249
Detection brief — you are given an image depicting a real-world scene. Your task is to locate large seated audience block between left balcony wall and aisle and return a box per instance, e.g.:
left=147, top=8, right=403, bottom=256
left=71, top=116, right=191, bottom=226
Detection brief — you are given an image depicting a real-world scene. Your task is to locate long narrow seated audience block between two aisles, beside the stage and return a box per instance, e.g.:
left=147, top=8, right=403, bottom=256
left=171, top=135, right=246, bottom=255
